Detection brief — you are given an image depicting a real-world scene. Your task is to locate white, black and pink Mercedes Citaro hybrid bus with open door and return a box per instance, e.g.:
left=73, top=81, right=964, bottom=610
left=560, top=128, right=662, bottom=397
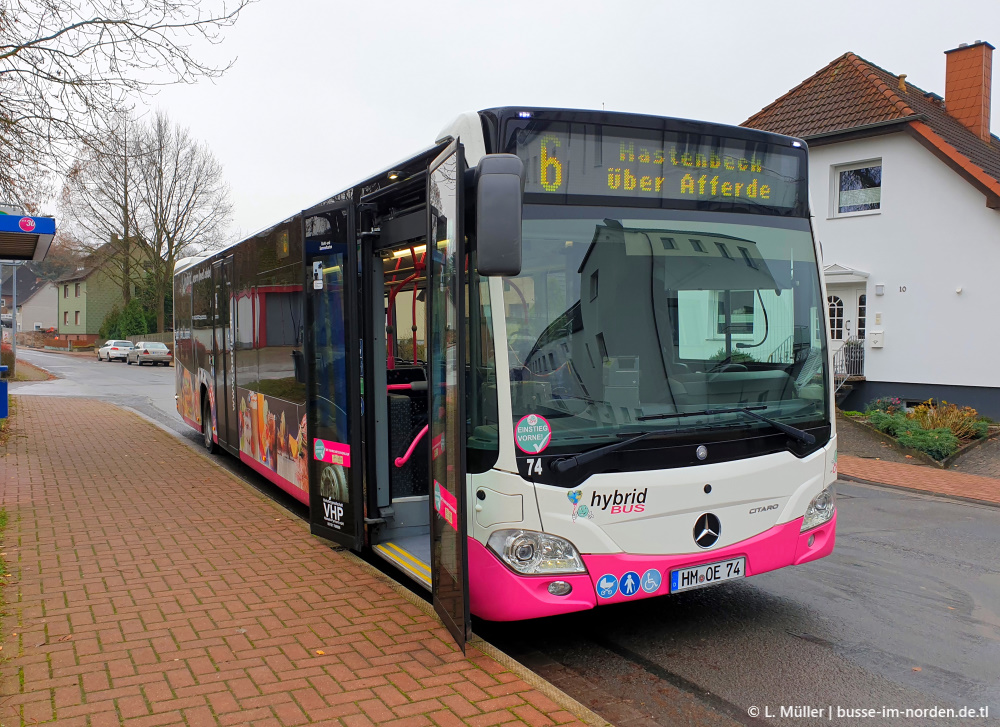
left=174, top=108, right=837, bottom=644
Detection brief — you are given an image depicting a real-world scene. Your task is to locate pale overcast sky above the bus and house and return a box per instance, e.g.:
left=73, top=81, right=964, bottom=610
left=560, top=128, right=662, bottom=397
left=137, top=0, right=1000, bottom=236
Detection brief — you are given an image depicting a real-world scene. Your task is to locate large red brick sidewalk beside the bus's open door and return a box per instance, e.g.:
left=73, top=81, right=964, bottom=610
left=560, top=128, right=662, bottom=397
left=0, top=397, right=581, bottom=727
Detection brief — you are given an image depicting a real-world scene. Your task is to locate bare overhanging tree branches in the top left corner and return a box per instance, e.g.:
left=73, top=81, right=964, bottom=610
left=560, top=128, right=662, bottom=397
left=0, top=0, right=252, bottom=202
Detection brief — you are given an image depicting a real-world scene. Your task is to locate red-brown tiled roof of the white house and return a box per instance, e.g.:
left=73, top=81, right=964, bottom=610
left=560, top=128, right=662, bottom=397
left=741, top=53, right=1000, bottom=201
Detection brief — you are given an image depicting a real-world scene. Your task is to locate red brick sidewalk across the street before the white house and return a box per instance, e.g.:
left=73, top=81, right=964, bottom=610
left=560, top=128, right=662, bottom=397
left=837, top=454, right=1000, bottom=504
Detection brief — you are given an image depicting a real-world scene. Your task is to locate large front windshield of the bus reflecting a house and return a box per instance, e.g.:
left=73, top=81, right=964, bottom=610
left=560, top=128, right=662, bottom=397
left=504, top=205, right=829, bottom=451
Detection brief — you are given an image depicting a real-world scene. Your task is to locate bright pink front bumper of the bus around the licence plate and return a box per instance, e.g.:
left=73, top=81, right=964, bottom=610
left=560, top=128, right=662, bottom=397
left=469, top=511, right=837, bottom=621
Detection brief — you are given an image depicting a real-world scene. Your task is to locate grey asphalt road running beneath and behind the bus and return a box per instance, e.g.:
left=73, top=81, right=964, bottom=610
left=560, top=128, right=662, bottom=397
left=13, top=351, right=1000, bottom=727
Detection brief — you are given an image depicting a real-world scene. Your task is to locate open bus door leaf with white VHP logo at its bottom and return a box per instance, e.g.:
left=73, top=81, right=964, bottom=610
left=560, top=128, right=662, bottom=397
left=306, top=202, right=364, bottom=550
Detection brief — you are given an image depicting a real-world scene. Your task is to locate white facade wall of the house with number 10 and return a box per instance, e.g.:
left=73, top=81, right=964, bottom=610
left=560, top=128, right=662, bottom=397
left=810, top=133, right=1000, bottom=392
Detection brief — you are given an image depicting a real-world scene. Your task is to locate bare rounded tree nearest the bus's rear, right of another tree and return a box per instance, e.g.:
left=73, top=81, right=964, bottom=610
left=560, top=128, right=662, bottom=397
left=139, top=112, right=232, bottom=331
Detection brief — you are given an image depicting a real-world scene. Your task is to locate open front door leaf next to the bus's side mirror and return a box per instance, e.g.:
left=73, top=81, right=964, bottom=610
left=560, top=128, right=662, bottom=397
left=427, top=141, right=469, bottom=652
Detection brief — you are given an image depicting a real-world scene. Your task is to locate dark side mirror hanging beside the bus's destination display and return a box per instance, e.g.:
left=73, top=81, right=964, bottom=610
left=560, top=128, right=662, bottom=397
left=476, top=154, right=524, bottom=276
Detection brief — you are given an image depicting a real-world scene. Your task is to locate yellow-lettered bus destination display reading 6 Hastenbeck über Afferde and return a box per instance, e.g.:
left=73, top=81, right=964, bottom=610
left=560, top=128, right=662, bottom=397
left=515, top=123, right=803, bottom=209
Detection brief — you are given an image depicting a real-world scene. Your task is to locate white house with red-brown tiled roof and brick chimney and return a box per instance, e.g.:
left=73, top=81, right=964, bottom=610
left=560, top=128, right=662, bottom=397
left=743, top=41, right=1000, bottom=417
